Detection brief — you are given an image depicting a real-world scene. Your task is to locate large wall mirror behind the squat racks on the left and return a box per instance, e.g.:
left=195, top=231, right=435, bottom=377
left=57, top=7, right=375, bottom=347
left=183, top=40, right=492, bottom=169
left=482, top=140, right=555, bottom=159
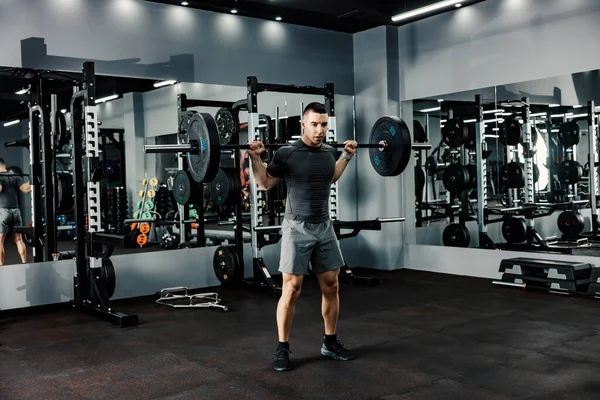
left=0, top=68, right=342, bottom=264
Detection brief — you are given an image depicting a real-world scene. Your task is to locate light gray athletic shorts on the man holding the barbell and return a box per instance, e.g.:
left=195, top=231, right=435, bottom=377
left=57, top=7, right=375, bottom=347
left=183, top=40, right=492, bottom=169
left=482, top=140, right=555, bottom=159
left=279, top=218, right=345, bottom=275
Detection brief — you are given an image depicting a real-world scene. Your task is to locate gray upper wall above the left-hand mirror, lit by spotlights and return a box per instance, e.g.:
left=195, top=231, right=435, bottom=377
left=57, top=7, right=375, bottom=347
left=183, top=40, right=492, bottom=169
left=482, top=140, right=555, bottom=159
left=0, top=0, right=353, bottom=94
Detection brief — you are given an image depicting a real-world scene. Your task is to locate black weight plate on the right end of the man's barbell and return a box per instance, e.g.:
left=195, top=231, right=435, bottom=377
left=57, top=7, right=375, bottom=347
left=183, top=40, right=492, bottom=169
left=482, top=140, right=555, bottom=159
left=369, top=117, right=412, bottom=176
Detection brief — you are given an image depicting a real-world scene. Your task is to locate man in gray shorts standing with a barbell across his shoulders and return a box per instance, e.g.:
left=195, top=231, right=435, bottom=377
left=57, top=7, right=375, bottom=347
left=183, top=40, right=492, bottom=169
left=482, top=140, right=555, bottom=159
left=248, top=103, right=357, bottom=371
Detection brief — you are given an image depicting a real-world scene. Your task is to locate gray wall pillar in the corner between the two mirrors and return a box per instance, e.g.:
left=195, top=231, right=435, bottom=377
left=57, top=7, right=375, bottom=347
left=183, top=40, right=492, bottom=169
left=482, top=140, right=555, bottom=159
left=354, top=27, right=415, bottom=269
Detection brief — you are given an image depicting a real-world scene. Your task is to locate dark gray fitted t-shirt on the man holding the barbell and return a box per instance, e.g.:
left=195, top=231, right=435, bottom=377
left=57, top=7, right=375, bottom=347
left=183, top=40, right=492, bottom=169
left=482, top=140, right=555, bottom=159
left=267, top=139, right=337, bottom=222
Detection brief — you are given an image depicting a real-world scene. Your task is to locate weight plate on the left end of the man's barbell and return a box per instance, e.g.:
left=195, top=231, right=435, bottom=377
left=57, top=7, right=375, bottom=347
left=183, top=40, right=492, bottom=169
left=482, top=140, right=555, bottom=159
left=187, top=113, right=221, bottom=182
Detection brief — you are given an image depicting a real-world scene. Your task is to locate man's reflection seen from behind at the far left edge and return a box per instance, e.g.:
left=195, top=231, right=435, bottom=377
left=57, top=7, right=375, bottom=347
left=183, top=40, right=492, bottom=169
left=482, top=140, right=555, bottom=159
left=0, top=158, right=31, bottom=265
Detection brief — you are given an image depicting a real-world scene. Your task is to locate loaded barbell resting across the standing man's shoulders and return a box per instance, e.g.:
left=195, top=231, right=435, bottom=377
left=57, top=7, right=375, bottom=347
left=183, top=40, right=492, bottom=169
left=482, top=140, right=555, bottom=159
left=144, top=111, right=431, bottom=183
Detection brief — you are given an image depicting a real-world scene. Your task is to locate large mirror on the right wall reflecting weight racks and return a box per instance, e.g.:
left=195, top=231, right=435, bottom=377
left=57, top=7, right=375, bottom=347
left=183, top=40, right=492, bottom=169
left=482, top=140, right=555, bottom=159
left=413, top=71, right=600, bottom=255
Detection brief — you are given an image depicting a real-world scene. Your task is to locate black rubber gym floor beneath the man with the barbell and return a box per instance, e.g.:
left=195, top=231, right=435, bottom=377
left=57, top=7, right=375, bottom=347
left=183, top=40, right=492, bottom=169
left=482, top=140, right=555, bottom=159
left=0, top=270, right=600, bottom=400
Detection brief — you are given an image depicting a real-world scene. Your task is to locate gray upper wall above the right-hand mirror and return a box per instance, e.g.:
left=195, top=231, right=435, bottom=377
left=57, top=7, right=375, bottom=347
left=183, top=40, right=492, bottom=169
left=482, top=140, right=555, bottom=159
left=398, top=0, right=600, bottom=100
